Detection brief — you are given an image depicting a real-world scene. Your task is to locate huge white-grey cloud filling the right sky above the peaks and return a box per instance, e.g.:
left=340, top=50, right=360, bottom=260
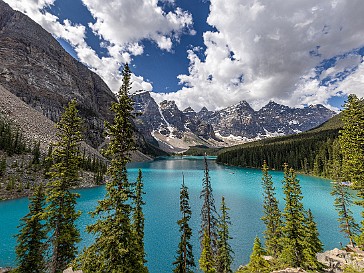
left=159, top=0, right=364, bottom=110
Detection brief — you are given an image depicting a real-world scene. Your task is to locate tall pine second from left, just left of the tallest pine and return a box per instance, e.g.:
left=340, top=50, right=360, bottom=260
left=46, top=100, right=82, bottom=273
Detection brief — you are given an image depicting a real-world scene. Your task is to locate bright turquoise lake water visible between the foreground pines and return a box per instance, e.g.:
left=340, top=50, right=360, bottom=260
left=0, top=157, right=360, bottom=273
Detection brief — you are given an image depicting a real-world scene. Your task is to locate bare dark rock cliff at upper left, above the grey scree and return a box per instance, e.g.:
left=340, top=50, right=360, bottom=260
left=0, top=0, right=115, bottom=147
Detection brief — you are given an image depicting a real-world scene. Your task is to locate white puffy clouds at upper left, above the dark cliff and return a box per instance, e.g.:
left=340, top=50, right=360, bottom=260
left=5, top=0, right=193, bottom=91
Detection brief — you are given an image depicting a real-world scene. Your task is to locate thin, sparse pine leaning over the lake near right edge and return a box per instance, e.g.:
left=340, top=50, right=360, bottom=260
left=331, top=180, right=359, bottom=246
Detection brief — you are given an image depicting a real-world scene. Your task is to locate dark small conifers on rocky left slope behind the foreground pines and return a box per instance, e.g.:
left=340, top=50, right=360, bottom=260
left=0, top=112, right=106, bottom=200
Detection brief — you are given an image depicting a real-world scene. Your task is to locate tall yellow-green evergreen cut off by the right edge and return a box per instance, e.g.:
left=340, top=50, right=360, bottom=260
left=339, top=95, right=364, bottom=248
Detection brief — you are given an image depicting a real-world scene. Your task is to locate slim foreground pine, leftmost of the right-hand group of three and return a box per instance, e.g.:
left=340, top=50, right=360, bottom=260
left=262, top=161, right=282, bottom=258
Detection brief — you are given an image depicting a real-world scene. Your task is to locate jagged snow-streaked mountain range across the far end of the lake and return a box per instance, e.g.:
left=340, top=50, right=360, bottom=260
left=132, top=92, right=335, bottom=151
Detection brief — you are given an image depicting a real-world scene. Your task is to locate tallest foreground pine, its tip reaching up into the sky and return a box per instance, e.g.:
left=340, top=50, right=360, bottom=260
left=77, top=64, right=145, bottom=273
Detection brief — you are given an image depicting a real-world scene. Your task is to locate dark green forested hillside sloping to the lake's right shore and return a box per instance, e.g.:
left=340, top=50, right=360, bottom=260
left=217, top=114, right=342, bottom=177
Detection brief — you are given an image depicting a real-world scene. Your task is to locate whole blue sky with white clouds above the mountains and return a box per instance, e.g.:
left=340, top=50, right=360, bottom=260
left=5, top=0, right=364, bottom=111
